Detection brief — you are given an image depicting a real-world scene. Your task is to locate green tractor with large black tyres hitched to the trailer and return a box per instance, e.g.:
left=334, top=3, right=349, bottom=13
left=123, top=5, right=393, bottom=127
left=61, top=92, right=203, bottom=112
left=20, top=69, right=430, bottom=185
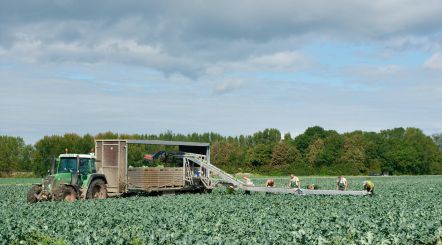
left=27, top=154, right=107, bottom=203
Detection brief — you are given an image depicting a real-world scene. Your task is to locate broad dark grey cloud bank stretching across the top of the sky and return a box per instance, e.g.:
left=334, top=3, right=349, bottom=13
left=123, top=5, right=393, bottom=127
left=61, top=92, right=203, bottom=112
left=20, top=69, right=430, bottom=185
left=0, top=0, right=442, bottom=79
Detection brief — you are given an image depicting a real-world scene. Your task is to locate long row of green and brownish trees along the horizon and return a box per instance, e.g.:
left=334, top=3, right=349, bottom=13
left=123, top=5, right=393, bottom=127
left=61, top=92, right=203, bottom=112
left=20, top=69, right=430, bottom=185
left=0, top=126, right=442, bottom=175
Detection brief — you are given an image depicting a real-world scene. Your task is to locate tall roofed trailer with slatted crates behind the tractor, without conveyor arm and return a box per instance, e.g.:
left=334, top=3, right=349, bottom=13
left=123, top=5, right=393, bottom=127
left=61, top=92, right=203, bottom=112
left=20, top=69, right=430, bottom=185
left=95, top=139, right=214, bottom=196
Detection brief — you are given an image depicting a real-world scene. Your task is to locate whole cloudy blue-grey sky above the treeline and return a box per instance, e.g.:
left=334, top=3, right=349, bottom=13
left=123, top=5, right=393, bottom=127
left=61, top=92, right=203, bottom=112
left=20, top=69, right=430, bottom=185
left=0, top=0, right=442, bottom=143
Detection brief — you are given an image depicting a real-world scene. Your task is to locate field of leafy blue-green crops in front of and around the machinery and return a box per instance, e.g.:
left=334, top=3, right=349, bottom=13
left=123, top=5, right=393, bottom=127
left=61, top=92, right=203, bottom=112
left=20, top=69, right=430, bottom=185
left=0, top=176, right=442, bottom=244
